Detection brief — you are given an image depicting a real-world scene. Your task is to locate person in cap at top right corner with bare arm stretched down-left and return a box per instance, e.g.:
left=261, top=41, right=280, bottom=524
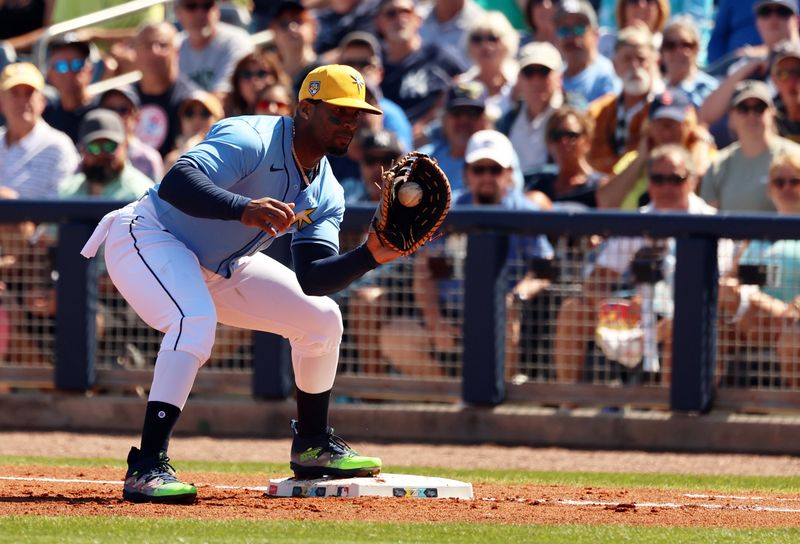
left=698, top=0, right=800, bottom=131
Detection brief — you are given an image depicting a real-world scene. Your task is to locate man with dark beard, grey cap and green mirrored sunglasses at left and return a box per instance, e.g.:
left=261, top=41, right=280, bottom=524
left=59, top=108, right=153, bottom=201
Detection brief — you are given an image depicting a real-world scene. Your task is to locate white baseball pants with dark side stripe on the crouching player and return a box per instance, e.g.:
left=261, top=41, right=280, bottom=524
left=82, top=197, right=343, bottom=408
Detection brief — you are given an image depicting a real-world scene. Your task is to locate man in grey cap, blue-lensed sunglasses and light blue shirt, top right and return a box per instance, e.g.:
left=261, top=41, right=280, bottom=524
left=553, top=0, right=622, bottom=104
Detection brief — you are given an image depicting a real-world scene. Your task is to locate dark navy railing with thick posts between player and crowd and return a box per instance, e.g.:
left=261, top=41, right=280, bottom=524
left=0, top=200, right=800, bottom=412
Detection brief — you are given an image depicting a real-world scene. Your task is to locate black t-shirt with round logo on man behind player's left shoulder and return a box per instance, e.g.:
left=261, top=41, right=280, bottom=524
left=134, top=78, right=199, bottom=157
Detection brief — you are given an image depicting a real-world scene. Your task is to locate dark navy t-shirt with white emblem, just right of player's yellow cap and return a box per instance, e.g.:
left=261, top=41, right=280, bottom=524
left=381, top=43, right=467, bottom=123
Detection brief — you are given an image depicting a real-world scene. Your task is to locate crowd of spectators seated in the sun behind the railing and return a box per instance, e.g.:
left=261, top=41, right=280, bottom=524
left=0, top=0, right=800, bottom=383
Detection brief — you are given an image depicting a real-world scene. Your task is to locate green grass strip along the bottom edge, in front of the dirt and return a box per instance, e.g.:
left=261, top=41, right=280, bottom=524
left=0, top=517, right=800, bottom=544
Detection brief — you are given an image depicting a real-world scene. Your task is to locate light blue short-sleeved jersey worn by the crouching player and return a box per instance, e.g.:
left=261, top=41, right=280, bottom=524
left=148, top=115, right=344, bottom=278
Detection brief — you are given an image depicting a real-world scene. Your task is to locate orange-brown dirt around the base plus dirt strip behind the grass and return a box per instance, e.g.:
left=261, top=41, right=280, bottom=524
left=0, top=433, right=800, bottom=528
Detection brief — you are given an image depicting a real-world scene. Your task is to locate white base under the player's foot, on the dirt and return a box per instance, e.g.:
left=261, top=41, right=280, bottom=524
left=266, top=473, right=472, bottom=499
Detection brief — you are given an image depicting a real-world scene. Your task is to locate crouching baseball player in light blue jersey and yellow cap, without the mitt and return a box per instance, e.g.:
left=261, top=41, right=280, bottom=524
left=81, top=65, right=398, bottom=503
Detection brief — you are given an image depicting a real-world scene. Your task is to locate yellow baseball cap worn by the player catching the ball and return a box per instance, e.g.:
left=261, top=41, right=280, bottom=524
left=297, top=64, right=383, bottom=115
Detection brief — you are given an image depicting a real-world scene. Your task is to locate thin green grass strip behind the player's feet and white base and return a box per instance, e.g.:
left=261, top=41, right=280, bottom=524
left=0, top=455, right=800, bottom=493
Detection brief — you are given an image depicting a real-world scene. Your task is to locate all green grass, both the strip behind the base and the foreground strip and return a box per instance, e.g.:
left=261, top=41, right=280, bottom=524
left=0, top=456, right=800, bottom=544
